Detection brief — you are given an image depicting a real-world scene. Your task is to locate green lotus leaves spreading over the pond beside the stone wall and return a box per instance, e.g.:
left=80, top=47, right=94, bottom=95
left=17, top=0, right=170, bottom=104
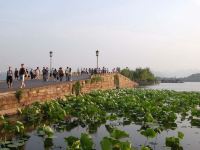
left=0, top=89, right=200, bottom=150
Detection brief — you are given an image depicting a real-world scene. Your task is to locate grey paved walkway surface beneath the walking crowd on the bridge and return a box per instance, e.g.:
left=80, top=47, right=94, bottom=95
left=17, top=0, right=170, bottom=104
left=0, top=74, right=90, bottom=93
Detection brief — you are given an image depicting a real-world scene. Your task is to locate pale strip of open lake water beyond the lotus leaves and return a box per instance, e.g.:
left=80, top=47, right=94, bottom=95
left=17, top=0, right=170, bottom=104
left=144, top=82, right=200, bottom=91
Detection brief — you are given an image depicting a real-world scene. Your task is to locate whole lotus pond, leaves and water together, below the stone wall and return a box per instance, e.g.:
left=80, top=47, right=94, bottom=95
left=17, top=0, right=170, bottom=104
left=0, top=89, right=200, bottom=150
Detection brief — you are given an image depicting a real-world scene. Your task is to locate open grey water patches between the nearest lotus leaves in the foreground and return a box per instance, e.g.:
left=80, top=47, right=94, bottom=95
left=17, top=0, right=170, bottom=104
left=25, top=120, right=200, bottom=150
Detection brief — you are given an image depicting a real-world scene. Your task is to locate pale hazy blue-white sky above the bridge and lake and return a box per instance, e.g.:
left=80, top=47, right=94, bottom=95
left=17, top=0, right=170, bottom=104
left=0, top=0, right=200, bottom=76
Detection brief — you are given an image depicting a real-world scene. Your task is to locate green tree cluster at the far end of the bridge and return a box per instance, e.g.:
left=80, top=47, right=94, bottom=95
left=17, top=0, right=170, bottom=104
left=120, top=68, right=156, bottom=85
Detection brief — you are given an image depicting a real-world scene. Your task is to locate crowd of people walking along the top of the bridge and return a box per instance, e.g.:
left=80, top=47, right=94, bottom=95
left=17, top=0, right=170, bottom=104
left=3, top=64, right=120, bottom=88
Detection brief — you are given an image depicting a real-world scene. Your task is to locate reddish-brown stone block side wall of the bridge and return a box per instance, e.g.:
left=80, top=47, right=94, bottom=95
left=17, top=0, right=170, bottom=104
left=0, top=74, right=137, bottom=115
